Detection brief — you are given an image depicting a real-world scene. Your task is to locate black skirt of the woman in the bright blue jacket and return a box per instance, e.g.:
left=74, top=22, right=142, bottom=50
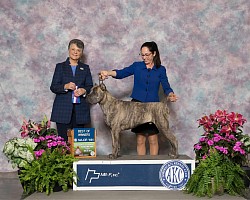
left=131, top=99, right=159, bottom=135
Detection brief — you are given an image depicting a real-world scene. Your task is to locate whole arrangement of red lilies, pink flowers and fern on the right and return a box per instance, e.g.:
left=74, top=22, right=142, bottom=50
left=185, top=110, right=250, bottom=197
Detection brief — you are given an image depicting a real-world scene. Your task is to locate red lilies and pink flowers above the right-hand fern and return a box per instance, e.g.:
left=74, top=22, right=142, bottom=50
left=194, top=110, right=250, bottom=165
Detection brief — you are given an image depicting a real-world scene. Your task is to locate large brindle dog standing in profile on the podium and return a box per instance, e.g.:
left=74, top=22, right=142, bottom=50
left=87, top=83, right=178, bottom=159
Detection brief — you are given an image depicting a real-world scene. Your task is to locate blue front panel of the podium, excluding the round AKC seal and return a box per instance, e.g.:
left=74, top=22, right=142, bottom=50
left=76, top=163, right=191, bottom=187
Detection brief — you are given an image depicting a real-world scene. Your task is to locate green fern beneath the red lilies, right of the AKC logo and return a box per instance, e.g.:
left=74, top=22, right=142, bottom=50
left=184, top=149, right=246, bottom=197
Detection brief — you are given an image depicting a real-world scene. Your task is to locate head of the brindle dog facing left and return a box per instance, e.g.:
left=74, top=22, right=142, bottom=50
left=86, top=83, right=107, bottom=104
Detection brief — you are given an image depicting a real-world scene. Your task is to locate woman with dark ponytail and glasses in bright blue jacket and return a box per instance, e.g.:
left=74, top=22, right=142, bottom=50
left=100, top=41, right=178, bottom=155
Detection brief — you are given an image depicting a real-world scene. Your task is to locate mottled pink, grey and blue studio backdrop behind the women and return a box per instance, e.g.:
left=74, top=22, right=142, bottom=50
left=0, top=0, right=250, bottom=171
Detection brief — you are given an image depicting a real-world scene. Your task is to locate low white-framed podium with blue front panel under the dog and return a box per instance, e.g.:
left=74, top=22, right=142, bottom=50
left=73, top=155, right=195, bottom=190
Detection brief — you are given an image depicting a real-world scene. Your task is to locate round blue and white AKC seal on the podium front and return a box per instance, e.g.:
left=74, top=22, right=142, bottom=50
left=159, top=160, right=190, bottom=190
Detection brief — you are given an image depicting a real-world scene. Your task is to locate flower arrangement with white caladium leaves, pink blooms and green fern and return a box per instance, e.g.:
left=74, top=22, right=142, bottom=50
left=3, top=116, right=77, bottom=195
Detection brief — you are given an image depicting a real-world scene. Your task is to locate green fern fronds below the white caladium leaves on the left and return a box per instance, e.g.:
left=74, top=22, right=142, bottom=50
left=19, top=148, right=77, bottom=195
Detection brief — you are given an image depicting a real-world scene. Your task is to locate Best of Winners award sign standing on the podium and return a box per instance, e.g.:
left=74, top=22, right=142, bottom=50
left=68, top=128, right=96, bottom=158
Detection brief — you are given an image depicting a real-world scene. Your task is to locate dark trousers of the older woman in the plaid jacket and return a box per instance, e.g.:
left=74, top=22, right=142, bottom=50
left=56, top=105, right=85, bottom=141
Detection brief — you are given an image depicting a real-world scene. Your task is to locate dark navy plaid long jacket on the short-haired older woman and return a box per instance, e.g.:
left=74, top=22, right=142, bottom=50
left=50, top=58, right=93, bottom=124
